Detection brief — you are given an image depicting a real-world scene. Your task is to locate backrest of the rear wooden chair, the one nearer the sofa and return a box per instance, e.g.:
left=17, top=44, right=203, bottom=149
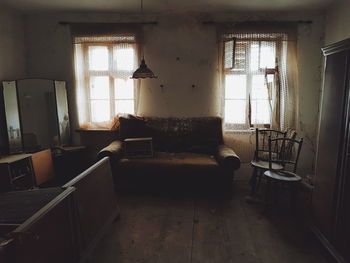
left=254, top=128, right=287, bottom=161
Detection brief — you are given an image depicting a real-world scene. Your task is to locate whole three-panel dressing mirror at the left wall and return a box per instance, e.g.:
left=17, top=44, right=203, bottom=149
left=3, top=79, right=70, bottom=153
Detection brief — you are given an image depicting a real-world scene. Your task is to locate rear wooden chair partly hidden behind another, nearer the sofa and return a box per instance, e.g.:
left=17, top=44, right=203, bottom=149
left=250, top=128, right=287, bottom=196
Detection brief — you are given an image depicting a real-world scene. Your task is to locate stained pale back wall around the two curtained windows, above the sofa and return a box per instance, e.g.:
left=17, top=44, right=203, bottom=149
left=25, top=10, right=324, bottom=173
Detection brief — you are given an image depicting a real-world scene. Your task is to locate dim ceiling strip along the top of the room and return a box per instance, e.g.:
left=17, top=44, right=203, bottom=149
left=0, top=0, right=338, bottom=13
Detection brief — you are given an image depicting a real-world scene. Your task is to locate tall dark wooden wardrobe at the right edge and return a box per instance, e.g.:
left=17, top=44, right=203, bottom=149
left=312, top=39, right=350, bottom=262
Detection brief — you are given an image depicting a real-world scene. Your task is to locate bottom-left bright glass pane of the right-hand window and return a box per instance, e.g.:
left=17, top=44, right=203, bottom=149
left=225, top=100, right=246, bottom=124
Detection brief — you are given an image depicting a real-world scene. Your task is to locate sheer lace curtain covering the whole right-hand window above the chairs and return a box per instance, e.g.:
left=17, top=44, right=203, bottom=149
left=220, top=24, right=298, bottom=130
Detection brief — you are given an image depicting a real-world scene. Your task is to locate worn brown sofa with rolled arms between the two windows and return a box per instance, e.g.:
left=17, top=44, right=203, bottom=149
left=98, top=115, right=240, bottom=195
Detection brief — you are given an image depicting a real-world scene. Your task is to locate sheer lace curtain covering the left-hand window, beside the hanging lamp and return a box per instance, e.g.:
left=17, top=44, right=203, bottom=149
left=71, top=24, right=139, bottom=129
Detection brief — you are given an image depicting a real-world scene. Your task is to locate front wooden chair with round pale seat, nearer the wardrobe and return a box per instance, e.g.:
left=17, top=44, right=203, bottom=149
left=264, top=137, right=303, bottom=207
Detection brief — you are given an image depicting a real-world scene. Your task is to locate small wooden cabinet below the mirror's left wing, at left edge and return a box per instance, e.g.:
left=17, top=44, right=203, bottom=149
left=0, top=154, right=35, bottom=192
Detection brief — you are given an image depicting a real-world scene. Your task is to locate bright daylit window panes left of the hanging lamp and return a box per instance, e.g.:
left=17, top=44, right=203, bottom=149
left=75, top=35, right=137, bottom=123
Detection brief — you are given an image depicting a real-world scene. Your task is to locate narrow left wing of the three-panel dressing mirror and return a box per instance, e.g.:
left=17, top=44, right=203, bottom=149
left=2, top=81, right=22, bottom=153
